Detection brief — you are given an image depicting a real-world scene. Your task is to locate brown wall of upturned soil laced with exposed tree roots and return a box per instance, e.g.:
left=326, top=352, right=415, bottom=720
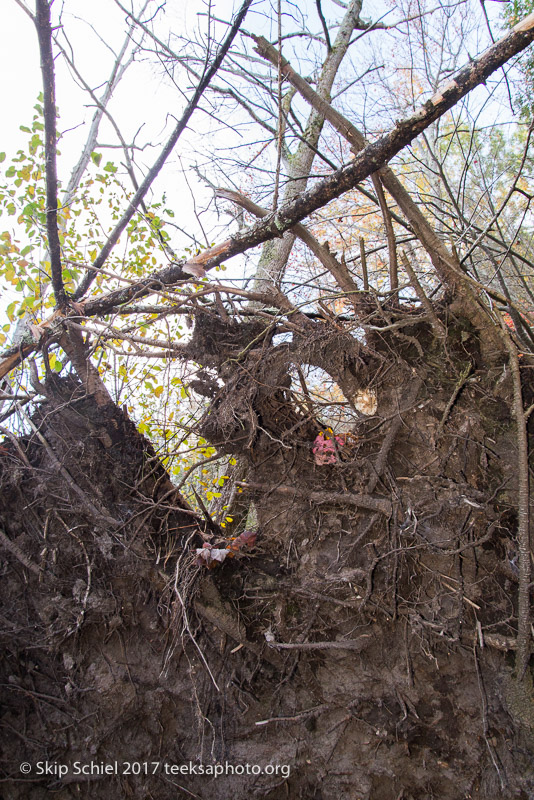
left=0, top=314, right=534, bottom=800
